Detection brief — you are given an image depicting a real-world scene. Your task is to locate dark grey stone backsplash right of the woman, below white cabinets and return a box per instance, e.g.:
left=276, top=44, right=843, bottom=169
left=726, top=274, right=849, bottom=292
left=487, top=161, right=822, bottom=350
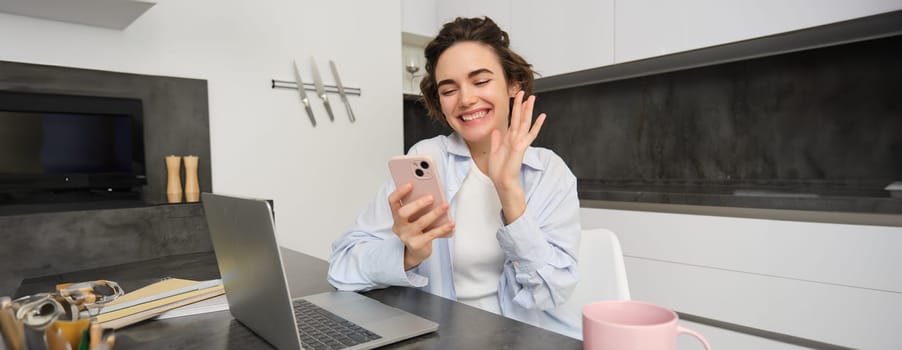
left=536, top=36, right=902, bottom=186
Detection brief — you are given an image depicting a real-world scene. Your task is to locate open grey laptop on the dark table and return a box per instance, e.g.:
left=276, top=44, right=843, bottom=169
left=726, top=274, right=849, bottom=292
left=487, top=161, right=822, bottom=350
left=202, top=193, right=438, bottom=349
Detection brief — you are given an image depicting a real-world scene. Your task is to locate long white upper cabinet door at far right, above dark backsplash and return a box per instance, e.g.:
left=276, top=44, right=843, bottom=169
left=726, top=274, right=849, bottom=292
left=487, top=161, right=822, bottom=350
left=614, top=0, right=902, bottom=63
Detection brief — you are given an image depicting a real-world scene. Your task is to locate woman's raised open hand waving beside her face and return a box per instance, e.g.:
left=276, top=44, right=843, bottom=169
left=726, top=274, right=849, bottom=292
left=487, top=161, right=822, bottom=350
left=488, top=91, right=545, bottom=223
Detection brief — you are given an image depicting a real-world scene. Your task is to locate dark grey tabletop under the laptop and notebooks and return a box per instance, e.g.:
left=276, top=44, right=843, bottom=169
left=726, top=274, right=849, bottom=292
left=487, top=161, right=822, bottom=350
left=16, top=248, right=582, bottom=350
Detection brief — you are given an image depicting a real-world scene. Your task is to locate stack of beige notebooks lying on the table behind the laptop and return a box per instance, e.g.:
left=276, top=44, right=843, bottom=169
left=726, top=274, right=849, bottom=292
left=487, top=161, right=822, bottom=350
left=96, top=278, right=224, bottom=329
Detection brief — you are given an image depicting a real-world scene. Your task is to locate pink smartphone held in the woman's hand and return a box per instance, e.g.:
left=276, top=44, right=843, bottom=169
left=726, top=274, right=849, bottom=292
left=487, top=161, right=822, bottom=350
left=388, top=155, right=450, bottom=231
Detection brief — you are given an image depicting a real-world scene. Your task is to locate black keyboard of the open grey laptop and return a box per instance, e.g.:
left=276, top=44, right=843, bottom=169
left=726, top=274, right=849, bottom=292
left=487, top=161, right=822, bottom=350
left=293, top=299, right=382, bottom=350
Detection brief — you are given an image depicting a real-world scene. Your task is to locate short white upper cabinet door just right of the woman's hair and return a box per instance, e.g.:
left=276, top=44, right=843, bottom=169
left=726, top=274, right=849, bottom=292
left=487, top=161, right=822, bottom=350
left=510, top=0, right=614, bottom=76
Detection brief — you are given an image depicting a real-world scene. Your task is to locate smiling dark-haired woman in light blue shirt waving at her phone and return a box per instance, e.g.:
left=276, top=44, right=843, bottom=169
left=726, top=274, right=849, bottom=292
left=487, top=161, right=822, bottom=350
left=329, top=18, right=580, bottom=336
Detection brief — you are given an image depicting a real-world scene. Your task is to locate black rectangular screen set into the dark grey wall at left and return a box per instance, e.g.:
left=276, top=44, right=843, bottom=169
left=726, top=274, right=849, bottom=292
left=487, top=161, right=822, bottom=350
left=0, top=91, right=146, bottom=194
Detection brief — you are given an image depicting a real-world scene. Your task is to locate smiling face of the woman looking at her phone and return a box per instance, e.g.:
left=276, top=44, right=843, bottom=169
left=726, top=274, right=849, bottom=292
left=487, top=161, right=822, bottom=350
left=435, top=41, right=519, bottom=145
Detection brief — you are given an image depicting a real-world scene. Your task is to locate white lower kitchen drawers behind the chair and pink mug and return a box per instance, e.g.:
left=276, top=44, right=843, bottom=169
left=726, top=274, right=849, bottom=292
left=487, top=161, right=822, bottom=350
left=581, top=208, right=902, bottom=349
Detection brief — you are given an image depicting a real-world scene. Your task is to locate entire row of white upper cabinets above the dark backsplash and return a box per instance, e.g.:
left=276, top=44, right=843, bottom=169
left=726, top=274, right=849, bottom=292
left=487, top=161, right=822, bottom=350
left=403, top=0, right=902, bottom=77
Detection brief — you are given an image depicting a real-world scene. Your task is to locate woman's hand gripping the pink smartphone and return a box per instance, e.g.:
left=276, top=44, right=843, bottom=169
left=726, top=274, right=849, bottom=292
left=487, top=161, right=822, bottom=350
left=388, top=183, right=454, bottom=271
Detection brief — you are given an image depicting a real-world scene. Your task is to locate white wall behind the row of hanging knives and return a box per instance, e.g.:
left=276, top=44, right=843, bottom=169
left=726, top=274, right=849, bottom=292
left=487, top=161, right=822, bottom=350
left=0, top=0, right=403, bottom=258
